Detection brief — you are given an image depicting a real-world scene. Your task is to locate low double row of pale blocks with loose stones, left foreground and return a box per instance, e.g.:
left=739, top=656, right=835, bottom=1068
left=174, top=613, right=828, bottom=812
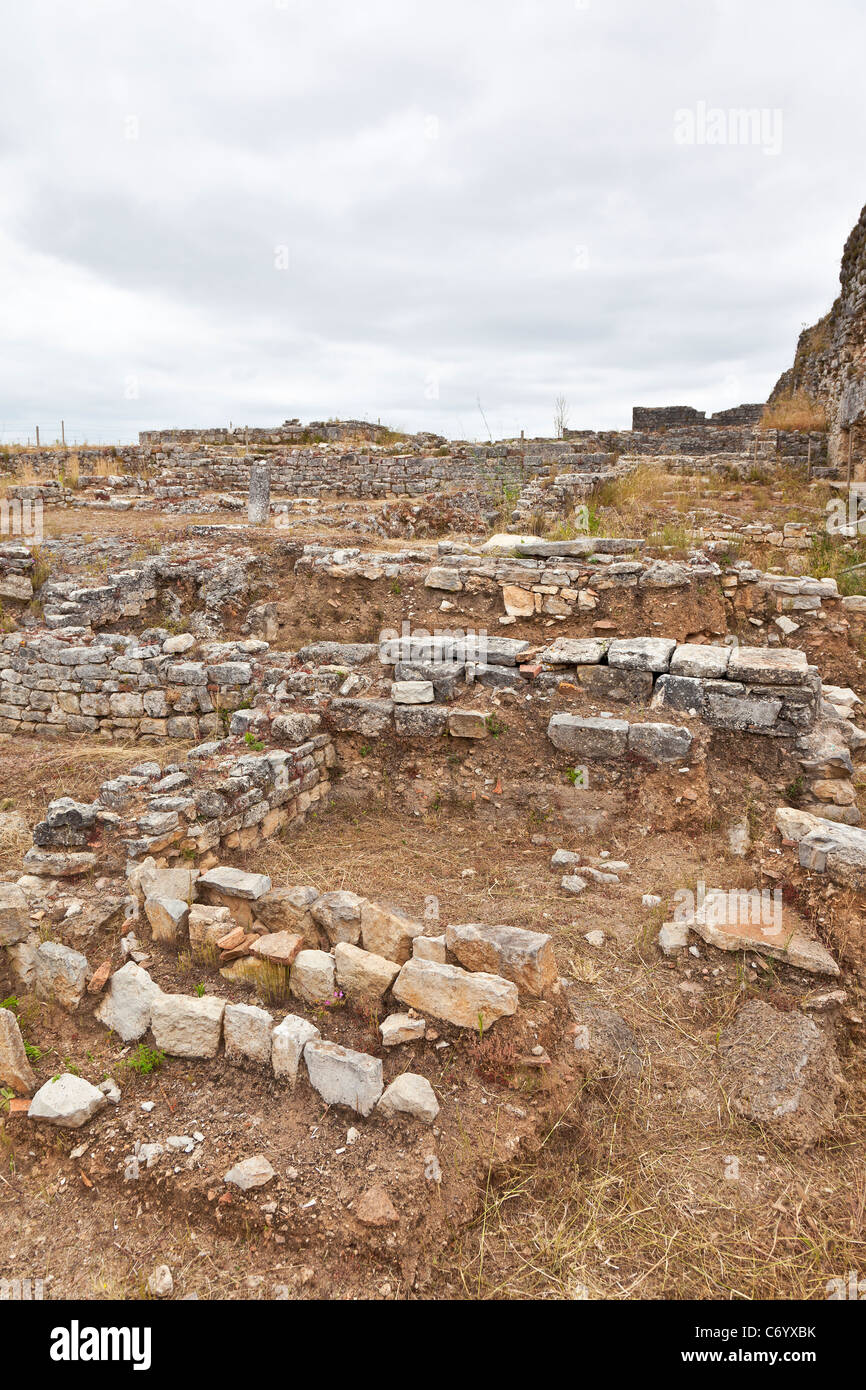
left=0, top=859, right=547, bottom=1123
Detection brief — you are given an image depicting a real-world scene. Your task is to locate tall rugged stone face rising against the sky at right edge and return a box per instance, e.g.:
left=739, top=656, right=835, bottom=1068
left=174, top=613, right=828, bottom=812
left=770, top=207, right=866, bottom=460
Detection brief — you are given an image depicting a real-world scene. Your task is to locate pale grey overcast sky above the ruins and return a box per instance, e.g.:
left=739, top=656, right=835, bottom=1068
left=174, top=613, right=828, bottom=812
left=0, top=0, right=866, bottom=441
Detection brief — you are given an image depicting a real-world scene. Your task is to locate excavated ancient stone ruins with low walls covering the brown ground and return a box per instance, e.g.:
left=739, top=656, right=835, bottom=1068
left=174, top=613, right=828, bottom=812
left=0, top=205, right=866, bottom=1298
